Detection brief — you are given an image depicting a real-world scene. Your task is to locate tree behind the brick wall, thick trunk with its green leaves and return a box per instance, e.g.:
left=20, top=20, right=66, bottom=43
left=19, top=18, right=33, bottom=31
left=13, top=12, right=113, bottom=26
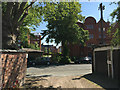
left=2, top=0, right=42, bottom=49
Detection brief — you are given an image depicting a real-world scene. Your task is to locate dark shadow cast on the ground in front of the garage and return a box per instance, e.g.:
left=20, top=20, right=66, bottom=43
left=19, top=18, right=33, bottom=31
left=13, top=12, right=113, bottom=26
left=82, top=74, right=118, bottom=89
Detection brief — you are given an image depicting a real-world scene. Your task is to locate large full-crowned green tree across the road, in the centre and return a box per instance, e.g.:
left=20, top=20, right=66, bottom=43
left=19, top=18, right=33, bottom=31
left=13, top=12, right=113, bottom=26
left=42, top=2, right=88, bottom=56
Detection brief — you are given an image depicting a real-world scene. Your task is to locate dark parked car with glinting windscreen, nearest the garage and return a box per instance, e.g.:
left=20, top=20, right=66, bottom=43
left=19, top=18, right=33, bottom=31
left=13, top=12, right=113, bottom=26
left=75, top=56, right=92, bottom=64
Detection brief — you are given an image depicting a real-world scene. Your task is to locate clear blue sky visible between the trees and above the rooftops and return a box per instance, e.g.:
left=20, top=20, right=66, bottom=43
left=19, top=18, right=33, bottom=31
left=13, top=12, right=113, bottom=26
left=33, top=2, right=117, bottom=47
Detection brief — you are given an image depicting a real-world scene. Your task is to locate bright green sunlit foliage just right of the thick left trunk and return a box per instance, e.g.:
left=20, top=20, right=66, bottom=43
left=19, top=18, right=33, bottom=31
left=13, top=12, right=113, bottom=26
left=19, top=4, right=42, bottom=48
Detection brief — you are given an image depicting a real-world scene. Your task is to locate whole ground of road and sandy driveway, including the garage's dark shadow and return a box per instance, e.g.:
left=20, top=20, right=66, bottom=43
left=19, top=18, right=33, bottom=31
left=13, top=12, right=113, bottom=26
left=23, top=64, right=117, bottom=90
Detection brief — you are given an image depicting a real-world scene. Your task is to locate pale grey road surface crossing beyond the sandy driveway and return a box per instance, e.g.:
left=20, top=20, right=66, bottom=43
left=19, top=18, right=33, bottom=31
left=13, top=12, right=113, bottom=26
left=27, top=64, right=92, bottom=77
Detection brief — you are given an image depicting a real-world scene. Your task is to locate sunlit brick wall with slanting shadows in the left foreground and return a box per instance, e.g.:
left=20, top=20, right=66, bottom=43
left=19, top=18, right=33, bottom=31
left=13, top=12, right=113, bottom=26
left=0, top=52, right=27, bottom=88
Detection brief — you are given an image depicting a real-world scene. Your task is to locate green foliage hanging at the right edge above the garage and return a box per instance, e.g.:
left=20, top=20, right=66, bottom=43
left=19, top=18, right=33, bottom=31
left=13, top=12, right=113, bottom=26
left=108, top=1, right=120, bottom=45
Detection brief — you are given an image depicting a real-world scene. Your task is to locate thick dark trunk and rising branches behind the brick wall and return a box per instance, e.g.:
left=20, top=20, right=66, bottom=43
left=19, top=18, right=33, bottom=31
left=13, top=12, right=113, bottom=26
left=2, top=0, right=36, bottom=49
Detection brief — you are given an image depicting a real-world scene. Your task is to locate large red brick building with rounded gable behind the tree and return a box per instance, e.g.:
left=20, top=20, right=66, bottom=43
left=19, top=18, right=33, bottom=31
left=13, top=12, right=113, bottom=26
left=69, top=17, right=111, bottom=57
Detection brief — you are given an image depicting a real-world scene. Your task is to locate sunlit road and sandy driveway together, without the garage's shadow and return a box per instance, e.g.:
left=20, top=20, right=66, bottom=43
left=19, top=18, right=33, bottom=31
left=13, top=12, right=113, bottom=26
left=24, top=64, right=96, bottom=88
